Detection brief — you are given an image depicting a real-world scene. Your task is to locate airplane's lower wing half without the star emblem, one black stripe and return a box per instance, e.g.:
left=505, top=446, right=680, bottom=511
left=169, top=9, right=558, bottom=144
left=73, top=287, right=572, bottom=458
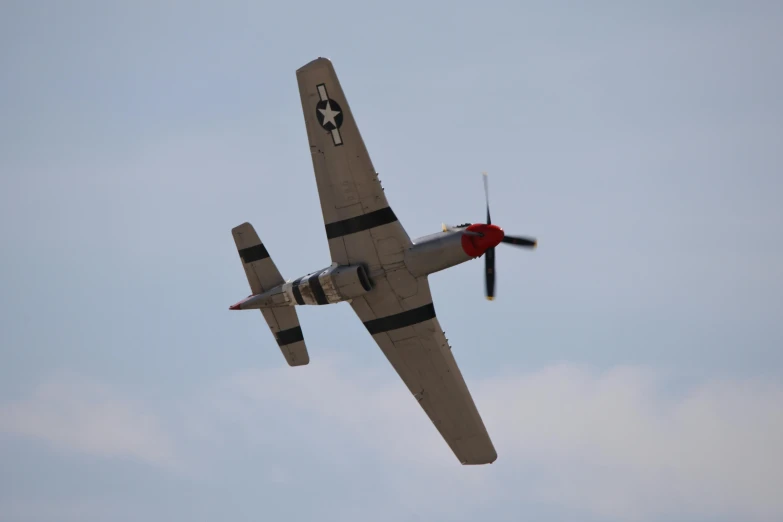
left=351, top=277, right=497, bottom=464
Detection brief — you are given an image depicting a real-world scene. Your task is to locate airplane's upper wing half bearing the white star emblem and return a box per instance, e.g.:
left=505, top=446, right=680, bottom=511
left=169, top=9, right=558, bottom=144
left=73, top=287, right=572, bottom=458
left=296, top=58, right=411, bottom=272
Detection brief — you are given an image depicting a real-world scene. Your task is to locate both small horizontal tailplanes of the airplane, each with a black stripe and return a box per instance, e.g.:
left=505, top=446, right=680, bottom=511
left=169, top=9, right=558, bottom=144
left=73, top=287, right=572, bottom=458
left=231, top=223, right=310, bottom=366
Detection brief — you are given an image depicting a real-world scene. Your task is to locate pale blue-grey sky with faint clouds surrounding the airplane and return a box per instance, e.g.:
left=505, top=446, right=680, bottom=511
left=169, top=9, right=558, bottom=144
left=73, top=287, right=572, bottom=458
left=0, top=1, right=783, bottom=522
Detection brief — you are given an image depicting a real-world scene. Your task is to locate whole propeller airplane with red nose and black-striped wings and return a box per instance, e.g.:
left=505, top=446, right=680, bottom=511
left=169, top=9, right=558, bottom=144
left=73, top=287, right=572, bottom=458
left=229, top=58, right=537, bottom=465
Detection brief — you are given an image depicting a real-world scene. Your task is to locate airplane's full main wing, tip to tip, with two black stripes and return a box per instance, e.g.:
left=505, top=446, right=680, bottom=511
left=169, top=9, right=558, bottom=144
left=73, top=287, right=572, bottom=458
left=296, top=58, right=497, bottom=464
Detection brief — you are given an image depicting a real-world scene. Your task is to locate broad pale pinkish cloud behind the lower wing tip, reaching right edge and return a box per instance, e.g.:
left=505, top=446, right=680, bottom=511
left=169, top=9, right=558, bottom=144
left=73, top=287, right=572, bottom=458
left=207, top=360, right=783, bottom=521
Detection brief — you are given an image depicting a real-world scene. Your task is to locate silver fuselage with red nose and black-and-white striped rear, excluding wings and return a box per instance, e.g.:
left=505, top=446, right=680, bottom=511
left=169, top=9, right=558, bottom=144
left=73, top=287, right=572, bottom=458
left=231, top=224, right=503, bottom=310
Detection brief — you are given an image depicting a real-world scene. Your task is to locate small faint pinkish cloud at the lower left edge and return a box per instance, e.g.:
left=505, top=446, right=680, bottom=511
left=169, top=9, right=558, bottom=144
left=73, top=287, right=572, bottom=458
left=0, top=372, right=174, bottom=467
